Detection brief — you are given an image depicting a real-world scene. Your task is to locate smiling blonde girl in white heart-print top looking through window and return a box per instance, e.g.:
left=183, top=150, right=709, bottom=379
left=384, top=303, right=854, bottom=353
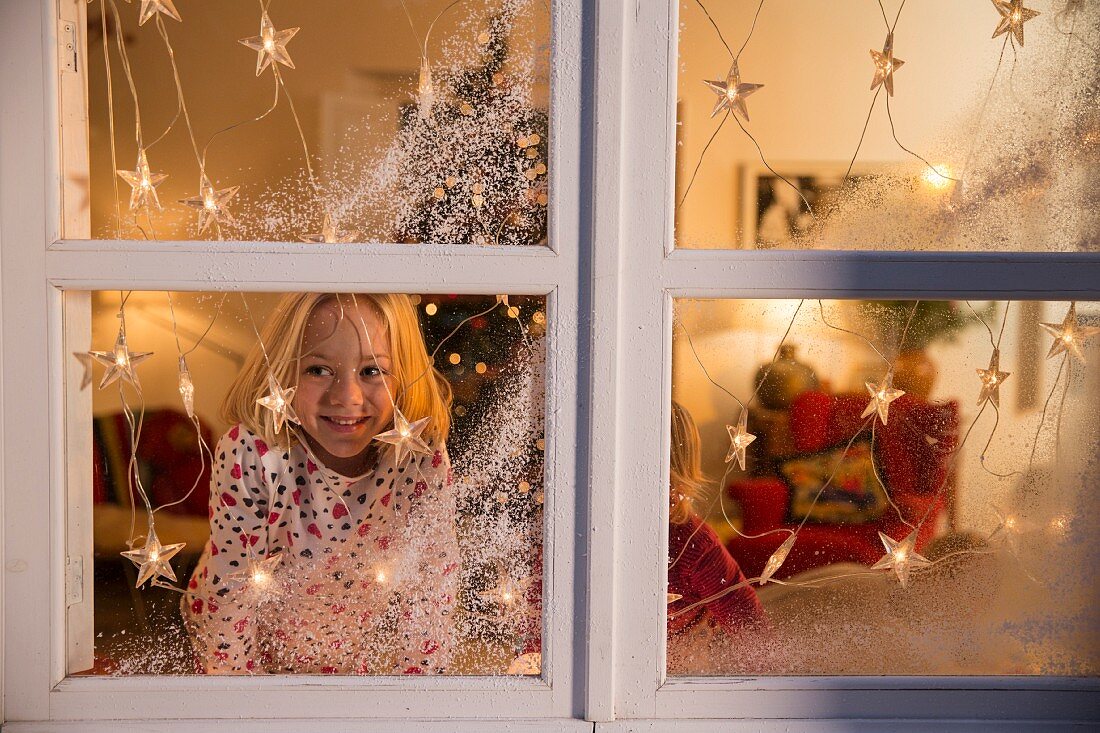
left=183, top=293, right=459, bottom=675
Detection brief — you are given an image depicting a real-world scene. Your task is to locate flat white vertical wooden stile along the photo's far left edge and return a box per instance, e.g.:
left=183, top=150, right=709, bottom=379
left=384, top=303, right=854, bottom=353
left=0, top=2, right=55, bottom=720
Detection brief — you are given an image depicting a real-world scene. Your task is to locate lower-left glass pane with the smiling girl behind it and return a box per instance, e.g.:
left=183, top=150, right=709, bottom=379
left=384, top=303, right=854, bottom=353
left=77, top=292, right=547, bottom=675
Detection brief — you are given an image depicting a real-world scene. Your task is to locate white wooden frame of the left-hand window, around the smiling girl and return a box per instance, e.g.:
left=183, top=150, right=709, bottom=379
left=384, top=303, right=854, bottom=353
left=0, top=0, right=592, bottom=732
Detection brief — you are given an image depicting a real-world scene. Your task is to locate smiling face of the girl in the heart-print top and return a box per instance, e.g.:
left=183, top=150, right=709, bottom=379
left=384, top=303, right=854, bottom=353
left=294, top=300, right=396, bottom=475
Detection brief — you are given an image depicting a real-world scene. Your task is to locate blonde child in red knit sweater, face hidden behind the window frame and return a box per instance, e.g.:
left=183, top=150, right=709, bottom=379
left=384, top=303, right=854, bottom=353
left=668, top=402, right=765, bottom=638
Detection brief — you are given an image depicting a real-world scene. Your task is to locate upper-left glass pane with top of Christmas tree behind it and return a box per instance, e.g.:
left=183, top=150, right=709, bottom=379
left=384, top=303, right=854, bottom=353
left=73, top=0, right=550, bottom=244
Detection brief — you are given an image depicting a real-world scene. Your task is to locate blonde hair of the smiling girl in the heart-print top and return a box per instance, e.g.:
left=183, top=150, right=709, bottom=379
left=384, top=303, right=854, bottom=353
left=221, top=293, right=451, bottom=448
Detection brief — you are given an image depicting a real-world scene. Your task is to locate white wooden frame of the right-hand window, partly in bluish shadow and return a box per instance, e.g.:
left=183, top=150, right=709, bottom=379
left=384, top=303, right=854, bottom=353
left=589, top=0, right=1100, bottom=732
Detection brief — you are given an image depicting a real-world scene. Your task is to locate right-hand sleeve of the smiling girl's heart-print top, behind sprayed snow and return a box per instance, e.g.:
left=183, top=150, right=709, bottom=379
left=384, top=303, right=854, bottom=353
left=395, top=446, right=460, bottom=675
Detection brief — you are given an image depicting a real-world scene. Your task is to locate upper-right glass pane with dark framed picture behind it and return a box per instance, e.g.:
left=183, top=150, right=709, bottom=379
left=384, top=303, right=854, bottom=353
left=670, top=0, right=1100, bottom=252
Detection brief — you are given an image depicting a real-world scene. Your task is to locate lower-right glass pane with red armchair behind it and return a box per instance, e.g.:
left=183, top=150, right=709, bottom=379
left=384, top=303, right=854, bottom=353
left=667, top=299, right=1100, bottom=676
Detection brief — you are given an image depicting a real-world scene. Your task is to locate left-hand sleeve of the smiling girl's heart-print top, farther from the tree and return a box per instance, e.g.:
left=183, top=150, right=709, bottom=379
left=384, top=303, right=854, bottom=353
left=183, top=426, right=268, bottom=674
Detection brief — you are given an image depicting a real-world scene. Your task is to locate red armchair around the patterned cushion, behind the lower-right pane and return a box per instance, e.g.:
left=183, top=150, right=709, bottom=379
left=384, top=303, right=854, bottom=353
left=727, top=392, right=958, bottom=579
